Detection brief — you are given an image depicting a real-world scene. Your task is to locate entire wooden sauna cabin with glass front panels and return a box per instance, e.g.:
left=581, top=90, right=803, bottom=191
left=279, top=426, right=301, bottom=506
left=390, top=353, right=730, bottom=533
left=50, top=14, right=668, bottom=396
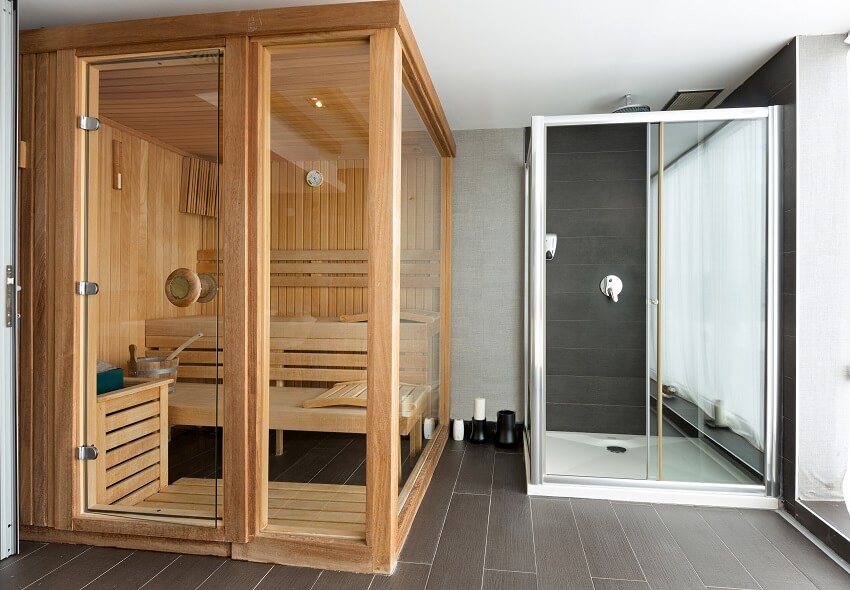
left=19, top=1, right=455, bottom=572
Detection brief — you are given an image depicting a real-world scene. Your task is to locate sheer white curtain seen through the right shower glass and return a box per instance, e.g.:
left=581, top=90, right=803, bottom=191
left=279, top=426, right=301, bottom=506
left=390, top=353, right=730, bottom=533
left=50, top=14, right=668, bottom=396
left=650, top=120, right=767, bottom=449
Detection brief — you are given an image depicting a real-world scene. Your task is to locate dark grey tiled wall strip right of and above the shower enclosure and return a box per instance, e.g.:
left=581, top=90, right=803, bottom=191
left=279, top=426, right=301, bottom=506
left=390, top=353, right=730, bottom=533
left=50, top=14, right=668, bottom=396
left=720, top=39, right=797, bottom=514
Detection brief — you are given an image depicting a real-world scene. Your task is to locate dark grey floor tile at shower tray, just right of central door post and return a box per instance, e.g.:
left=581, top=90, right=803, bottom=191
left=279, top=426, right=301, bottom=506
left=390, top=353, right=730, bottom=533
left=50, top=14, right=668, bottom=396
left=655, top=505, right=759, bottom=589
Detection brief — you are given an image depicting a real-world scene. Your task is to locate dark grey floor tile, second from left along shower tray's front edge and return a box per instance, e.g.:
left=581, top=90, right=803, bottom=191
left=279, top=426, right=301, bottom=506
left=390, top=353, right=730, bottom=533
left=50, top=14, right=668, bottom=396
left=570, top=499, right=644, bottom=580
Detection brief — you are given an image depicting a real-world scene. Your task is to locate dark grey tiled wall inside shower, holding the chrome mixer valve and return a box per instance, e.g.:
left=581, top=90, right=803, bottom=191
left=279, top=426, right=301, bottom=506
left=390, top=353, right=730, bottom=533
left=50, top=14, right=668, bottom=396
left=546, top=125, right=646, bottom=434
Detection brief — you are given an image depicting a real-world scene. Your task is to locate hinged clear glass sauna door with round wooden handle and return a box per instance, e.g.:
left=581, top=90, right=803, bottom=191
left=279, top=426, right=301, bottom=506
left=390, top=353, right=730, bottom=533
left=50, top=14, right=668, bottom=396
left=78, top=51, right=224, bottom=526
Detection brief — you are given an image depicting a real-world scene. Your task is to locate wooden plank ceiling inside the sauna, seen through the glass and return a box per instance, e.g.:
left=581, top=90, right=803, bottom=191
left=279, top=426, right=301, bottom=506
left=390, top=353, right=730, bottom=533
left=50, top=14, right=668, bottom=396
left=99, top=43, right=434, bottom=161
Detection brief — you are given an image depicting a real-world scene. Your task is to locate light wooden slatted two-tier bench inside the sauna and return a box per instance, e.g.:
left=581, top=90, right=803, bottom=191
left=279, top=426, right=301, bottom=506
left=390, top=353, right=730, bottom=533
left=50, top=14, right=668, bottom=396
left=145, top=310, right=440, bottom=454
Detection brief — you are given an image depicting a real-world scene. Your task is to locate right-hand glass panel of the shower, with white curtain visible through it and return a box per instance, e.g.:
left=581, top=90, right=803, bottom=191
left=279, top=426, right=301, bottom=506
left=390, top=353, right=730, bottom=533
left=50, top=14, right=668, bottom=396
left=648, top=119, right=767, bottom=484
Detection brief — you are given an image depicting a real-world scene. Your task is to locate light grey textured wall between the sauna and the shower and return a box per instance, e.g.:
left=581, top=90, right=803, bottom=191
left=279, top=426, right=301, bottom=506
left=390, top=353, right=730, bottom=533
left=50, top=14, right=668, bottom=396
left=451, top=129, right=525, bottom=420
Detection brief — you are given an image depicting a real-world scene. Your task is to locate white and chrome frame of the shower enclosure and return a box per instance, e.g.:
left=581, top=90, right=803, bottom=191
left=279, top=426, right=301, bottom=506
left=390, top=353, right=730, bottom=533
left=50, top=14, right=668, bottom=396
left=524, top=107, right=782, bottom=509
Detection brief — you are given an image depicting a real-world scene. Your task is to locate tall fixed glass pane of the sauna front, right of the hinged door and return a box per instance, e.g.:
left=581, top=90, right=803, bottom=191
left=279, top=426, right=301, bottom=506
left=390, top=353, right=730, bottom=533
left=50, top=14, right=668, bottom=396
left=264, top=40, right=373, bottom=539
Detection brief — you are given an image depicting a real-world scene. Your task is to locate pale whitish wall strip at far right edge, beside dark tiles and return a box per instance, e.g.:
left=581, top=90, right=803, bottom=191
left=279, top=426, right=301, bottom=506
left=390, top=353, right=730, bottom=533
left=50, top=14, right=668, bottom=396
left=796, top=35, right=850, bottom=500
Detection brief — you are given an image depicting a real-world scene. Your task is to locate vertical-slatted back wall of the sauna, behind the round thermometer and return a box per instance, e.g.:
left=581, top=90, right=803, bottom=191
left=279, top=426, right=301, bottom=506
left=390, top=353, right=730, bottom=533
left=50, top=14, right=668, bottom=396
left=270, top=156, right=441, bottom=317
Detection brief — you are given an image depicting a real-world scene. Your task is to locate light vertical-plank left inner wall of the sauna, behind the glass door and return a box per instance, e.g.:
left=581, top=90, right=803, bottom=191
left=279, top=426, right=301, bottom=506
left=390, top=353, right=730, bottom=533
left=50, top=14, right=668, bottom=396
left=90, top=124, right=219, bottom=368
